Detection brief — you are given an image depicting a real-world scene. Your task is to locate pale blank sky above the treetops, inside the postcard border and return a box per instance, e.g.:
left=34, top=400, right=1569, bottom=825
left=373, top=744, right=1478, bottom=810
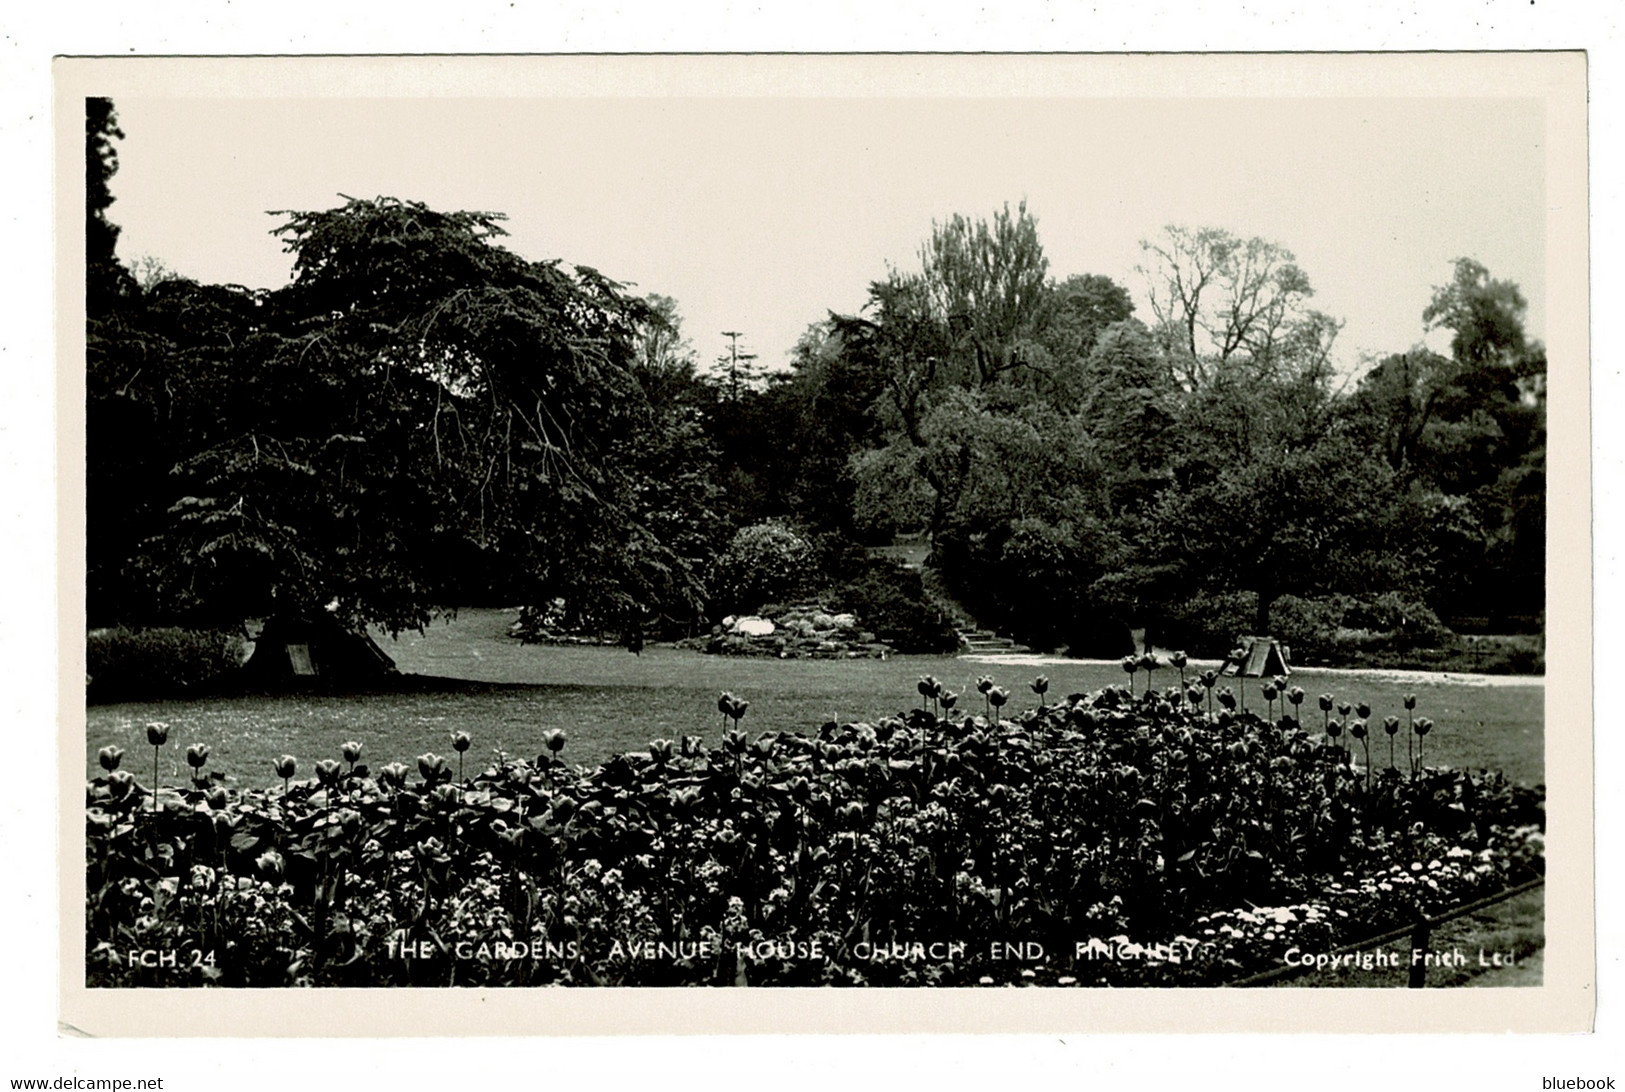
left=109, top=82, right=1545, bottom=380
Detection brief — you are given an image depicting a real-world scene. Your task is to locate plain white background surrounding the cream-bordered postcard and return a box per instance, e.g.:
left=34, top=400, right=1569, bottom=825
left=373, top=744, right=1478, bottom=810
left=0, top=0, right=1625, bottom=1090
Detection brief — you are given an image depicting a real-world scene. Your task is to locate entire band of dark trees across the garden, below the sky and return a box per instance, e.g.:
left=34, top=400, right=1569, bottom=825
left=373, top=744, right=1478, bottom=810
left=86, top=99, right=1545, bottom=653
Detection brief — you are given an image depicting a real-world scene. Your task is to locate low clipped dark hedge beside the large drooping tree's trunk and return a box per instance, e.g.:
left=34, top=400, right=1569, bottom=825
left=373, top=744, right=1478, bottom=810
left=85, top=627, right=247, bottom=702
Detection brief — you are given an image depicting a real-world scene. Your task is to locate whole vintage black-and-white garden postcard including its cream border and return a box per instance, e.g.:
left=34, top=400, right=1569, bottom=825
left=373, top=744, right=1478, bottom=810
left=57, top=54, right=1594, bottom=1030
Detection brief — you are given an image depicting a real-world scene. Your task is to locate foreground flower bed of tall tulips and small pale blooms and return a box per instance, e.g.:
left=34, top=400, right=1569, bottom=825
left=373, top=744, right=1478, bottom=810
left=86, top=687, right=1544, bottom=986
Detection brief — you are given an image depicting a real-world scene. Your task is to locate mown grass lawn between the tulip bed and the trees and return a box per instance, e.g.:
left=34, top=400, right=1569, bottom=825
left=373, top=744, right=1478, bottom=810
left=86, top=609, right=1545, bottom=787
